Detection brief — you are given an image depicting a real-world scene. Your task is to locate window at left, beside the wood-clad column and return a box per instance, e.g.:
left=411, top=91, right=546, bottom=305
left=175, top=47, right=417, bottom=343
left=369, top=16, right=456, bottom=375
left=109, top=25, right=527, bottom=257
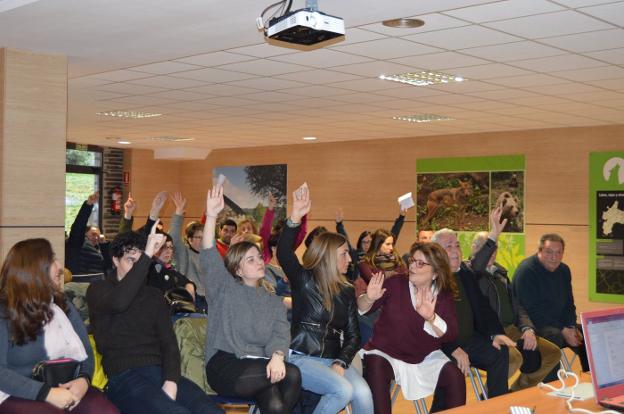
left=65, top=143, right=102, bottom=234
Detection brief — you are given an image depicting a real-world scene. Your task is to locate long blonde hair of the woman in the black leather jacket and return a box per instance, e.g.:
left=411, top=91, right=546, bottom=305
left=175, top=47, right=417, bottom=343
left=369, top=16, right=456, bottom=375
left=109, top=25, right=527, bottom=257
left=303, top=232, right=350, bottom=311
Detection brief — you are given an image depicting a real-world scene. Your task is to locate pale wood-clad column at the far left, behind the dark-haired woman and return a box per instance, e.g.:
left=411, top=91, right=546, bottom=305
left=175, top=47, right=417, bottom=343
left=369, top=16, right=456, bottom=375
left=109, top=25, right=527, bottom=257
left=0, top=49, right=67, bottom=261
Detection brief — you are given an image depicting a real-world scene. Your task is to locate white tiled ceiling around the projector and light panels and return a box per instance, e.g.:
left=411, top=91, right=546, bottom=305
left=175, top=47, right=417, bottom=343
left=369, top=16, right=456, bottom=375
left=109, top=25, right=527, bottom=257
left=0, top=0, right=624, bottom=149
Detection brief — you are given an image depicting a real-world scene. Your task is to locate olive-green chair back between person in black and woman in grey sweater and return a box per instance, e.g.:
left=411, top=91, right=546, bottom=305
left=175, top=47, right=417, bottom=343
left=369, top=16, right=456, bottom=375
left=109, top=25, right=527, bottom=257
left=173, top=315, right=216, bottom=395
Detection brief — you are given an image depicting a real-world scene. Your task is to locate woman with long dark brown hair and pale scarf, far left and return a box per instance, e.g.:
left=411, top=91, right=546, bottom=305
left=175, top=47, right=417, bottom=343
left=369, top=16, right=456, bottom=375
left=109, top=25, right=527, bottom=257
left=0, top=239, right=119, bottom=414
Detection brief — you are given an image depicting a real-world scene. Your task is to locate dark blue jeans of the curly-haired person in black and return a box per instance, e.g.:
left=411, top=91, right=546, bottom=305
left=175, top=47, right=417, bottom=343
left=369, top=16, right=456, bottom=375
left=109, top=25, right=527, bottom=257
left=106, top=365, right=224, bottom=414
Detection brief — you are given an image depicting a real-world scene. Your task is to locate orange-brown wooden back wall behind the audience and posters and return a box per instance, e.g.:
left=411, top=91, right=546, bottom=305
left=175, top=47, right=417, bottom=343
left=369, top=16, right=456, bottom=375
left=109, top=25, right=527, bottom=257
left=128, top=126, right=624, bottom=310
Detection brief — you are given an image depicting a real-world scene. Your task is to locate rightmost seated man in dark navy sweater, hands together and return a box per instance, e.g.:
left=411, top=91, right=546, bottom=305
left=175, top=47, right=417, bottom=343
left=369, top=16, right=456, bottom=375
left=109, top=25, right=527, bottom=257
left=512, top=233, right=589, bottom=382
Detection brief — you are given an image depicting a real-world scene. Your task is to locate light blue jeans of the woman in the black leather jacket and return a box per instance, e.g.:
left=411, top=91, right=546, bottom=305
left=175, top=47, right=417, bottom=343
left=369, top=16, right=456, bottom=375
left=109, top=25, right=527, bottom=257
left=289, top=354, right=373, bottom=414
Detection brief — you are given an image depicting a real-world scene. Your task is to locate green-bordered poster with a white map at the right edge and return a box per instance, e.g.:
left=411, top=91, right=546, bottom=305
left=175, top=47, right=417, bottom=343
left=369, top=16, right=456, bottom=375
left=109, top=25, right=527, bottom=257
left=589, top=152, right=624, bottom=303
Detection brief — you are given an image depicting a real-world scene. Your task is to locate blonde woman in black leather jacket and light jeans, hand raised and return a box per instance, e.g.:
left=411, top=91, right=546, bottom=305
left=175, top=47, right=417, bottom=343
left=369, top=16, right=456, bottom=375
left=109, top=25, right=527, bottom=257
left=277, top=184, right=373, bottom=414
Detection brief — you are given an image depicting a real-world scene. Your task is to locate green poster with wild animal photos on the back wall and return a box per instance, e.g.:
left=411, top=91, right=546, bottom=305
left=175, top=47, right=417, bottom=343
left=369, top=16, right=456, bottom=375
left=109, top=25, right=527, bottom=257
left=416, top=155, right=525, bottom=276
